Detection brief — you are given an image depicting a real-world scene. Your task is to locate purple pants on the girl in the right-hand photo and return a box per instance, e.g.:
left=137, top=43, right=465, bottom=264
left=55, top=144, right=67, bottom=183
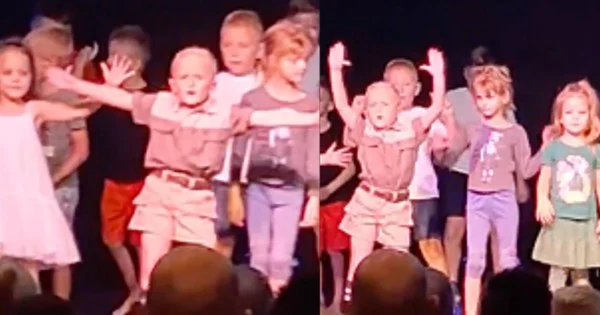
left=466, top=190, right=519, bottom=278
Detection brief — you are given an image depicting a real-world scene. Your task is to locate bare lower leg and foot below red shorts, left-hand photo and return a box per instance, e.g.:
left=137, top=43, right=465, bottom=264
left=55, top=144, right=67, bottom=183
left=109, top=244, right=142, bottom=315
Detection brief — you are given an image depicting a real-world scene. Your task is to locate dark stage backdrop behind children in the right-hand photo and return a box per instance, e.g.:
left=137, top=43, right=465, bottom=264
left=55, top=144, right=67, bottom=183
left=321, top=0, right=600, bottom=284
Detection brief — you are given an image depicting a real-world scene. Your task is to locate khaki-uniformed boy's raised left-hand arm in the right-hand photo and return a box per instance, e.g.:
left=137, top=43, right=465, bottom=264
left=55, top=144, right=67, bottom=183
left=329, top=43, right=359, bottom=129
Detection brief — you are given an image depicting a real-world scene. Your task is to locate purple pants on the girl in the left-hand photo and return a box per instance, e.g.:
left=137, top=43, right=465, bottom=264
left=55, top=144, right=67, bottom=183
left=246, top=184, right=306, bottom=281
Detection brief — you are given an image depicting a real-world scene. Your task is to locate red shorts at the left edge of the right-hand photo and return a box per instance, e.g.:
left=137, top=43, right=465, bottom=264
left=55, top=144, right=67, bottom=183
left=319, top=201, right=350, bottom=251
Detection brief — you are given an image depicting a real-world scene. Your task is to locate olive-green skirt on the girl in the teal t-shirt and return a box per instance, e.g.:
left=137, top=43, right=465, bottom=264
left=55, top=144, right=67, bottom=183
left=532, top=218, right=600, bottom=269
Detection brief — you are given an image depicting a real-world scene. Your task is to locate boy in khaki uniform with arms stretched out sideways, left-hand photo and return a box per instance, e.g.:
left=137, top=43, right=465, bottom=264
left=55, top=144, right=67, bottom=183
left=47, top=47, right=319, bottom=300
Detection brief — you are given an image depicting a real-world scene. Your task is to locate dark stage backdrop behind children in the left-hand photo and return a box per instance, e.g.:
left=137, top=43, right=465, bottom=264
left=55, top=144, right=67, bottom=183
left=0, top=0, right=298, bottom=315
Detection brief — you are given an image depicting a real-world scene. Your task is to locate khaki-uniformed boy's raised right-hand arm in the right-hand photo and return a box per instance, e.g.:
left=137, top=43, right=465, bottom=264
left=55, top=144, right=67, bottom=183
left=421, top=49, right=446, bottom=129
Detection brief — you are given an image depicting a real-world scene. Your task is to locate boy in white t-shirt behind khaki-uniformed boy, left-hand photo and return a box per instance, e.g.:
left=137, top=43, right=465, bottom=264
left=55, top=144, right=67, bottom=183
left=212, top=10, right=263, bottom=257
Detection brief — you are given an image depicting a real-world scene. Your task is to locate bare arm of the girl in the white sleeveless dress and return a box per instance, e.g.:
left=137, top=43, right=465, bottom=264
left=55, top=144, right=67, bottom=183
left=29, top=101, right=100, bottom=121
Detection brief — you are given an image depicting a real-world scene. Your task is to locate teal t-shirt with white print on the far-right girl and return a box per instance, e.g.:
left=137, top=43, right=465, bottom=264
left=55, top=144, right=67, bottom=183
left=542, top=139, right=600, bottom=220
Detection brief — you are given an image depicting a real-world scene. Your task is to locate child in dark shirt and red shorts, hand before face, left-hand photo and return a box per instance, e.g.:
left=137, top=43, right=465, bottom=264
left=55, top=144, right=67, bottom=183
left=93, top=25, right=150, bottom=315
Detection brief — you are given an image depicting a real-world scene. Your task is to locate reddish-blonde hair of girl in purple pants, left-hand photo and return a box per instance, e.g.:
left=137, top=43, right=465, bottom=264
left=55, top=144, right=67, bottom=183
left=262, top=20, right=315, bottom=76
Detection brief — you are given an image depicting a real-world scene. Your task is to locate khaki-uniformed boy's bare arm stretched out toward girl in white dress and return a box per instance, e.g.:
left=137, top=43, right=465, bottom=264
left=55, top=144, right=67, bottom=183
left=47, top=68, right=133, bottom=111
